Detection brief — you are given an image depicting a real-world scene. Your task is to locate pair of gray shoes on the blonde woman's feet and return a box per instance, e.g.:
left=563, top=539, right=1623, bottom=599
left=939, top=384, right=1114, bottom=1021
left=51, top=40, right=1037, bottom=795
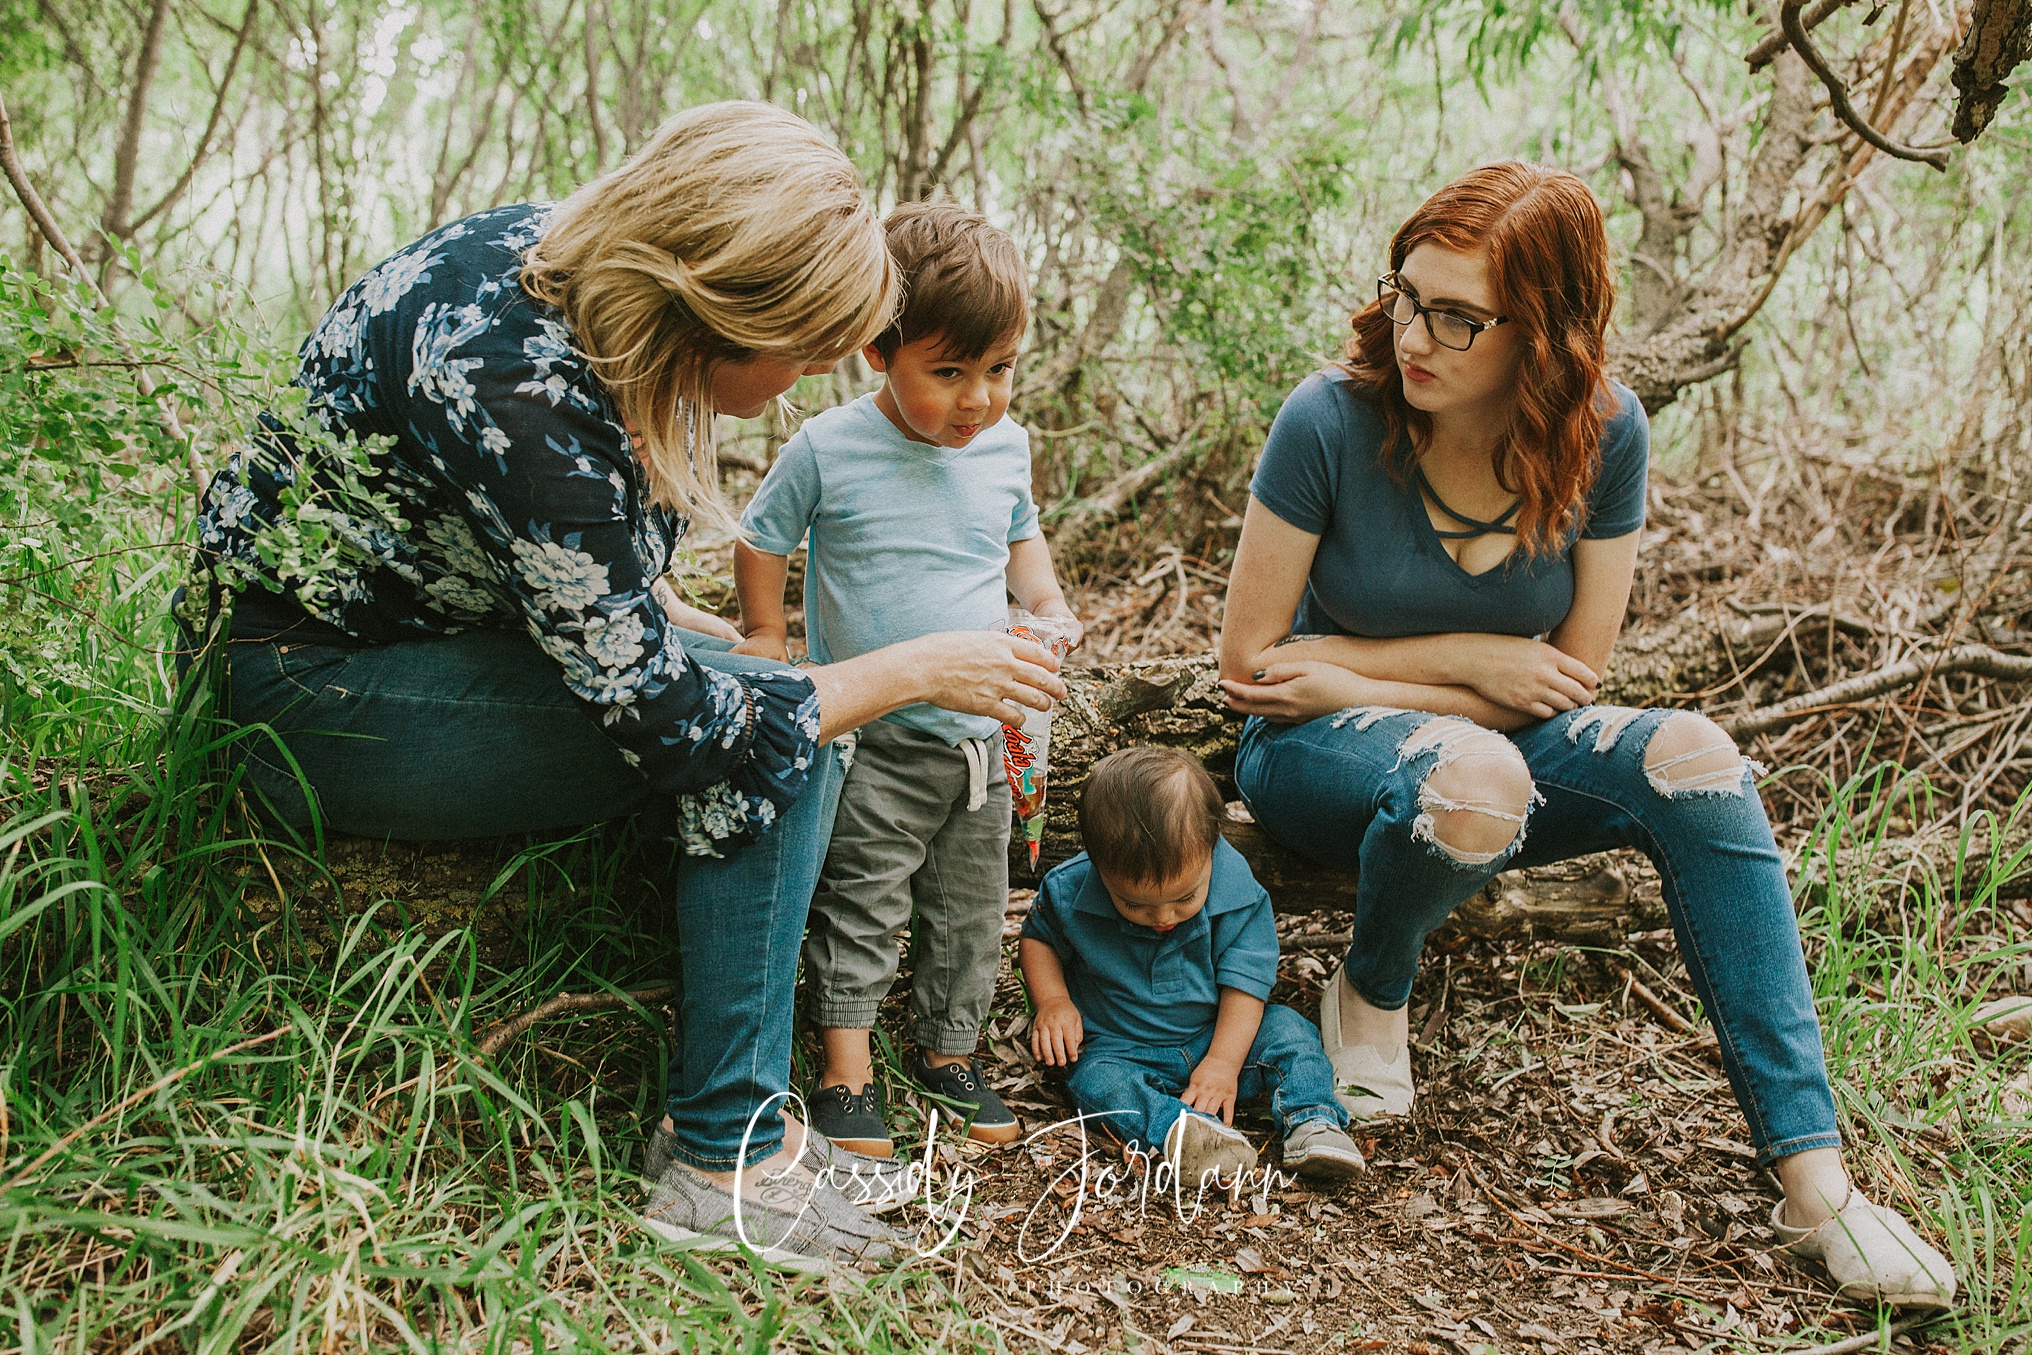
left=642, top=1162, right=910, bottom=1270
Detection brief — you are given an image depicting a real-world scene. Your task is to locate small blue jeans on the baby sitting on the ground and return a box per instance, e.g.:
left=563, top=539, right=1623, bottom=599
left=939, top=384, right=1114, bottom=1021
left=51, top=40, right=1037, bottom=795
left=1067, top=1004, right=1347, bottom=1152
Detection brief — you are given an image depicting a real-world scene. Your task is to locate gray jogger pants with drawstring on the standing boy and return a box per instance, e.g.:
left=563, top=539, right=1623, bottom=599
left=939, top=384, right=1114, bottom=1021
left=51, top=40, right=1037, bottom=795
left=805, top=719, right=1010, bottom=1054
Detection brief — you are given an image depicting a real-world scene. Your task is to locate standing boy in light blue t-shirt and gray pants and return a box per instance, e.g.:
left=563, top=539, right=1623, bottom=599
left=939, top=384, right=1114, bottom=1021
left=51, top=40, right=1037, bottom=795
left=734, top=203, right=1073, bottom=1156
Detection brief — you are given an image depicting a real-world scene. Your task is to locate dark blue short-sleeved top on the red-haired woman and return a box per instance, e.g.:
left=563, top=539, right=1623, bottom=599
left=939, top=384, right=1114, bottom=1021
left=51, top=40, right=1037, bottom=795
left=1250, top=368, right=1650, bottom=640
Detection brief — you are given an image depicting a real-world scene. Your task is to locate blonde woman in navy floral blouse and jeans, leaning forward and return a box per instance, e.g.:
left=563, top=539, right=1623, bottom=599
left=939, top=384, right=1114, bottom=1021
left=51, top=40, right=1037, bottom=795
left=197, top=104, right=1063, bottom=1260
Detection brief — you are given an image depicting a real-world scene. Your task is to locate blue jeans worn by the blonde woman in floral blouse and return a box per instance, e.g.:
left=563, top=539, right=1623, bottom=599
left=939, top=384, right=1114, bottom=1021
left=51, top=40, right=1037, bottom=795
left=210, top=630, right=841, bottom=1170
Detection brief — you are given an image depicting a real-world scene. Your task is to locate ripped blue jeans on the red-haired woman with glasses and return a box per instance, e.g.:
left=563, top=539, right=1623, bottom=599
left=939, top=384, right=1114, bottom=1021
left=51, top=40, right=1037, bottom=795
left=1235, top=705, right=1841, bottom=1164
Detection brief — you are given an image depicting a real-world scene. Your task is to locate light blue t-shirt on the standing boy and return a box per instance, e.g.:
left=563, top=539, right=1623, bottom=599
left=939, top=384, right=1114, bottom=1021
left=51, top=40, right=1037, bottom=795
left=742, top=394, right=1038, bottom=746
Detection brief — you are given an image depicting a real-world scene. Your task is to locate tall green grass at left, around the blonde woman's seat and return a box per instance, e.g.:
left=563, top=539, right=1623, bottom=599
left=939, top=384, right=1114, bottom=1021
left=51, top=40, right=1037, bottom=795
left=0, top=536, right=1011, bottom=1355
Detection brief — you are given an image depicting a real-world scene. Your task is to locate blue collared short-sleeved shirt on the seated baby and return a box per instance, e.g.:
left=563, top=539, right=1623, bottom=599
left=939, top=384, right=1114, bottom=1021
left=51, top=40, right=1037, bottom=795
left=1022, top=841, right=1276, bottom=1048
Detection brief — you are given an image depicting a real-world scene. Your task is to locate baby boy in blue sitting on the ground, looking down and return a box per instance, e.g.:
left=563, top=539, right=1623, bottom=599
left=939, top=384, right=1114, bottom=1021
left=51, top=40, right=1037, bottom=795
left=1020, top=748, right=1363, bottom=1188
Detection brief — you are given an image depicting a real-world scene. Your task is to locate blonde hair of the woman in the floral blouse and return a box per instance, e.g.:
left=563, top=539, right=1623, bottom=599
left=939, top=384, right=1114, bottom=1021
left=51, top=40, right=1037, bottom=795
left=522, top=102, right=898, bottom=530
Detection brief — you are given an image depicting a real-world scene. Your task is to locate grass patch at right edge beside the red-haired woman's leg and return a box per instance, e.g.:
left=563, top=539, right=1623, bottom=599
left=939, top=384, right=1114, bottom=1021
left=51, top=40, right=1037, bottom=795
left=1798, top=766, right=2032, bottom=1351
